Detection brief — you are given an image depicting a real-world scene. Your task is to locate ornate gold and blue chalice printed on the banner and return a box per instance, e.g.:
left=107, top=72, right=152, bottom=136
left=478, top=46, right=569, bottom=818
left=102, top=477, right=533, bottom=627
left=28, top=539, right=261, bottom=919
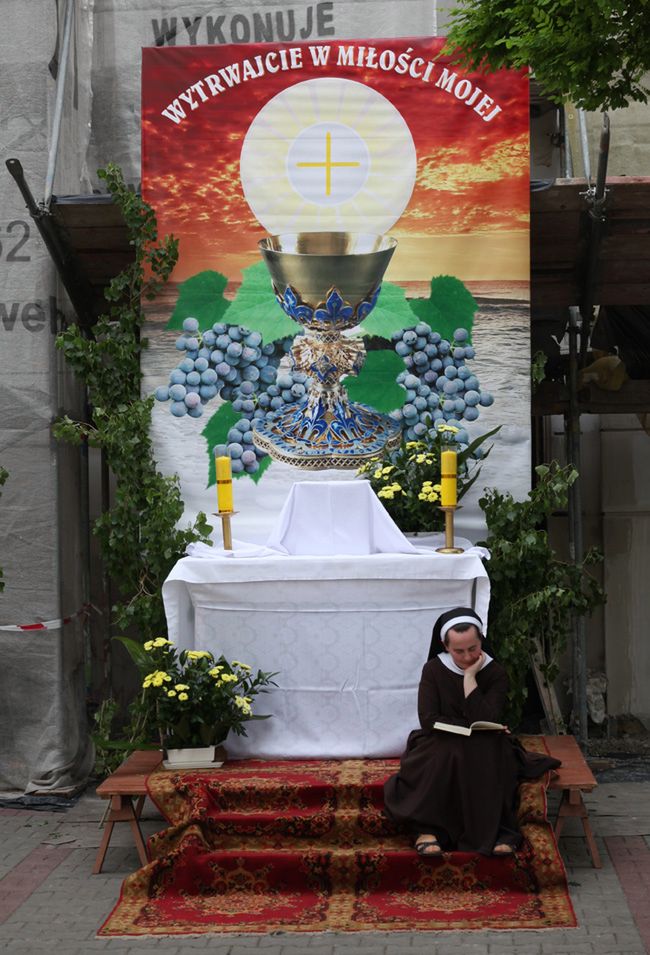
left=254, top=232, right=401, bottom=470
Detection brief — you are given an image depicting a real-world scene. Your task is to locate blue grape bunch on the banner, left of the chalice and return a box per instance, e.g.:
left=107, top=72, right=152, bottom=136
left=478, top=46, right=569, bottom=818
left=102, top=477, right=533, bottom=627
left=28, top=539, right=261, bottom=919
left=155, top=318, right=309, bottom=474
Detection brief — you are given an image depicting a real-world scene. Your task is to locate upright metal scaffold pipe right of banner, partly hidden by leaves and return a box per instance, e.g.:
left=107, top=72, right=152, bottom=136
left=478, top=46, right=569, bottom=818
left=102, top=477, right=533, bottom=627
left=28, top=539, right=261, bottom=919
left=565, top=306, right=589, bottom=745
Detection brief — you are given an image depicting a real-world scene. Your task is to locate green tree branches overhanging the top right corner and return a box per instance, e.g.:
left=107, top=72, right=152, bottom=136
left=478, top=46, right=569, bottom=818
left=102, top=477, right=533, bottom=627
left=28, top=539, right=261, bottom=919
left=446, top=0, right=650, bottom=111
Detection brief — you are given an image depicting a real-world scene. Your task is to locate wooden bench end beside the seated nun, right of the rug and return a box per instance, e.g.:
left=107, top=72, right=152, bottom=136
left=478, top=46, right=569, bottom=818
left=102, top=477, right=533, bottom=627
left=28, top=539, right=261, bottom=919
left=544, top=736, right=602, bottom=869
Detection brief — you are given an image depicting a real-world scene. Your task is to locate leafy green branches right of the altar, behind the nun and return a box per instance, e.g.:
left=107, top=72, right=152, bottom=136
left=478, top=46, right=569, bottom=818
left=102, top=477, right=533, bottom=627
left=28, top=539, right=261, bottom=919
left=479, top=461, right=605, bottom=726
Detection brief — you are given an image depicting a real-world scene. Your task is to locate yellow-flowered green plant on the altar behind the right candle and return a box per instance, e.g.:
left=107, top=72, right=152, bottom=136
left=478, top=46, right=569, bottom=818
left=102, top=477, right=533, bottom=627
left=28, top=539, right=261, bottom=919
left=357, top=423, right=499, bottom=533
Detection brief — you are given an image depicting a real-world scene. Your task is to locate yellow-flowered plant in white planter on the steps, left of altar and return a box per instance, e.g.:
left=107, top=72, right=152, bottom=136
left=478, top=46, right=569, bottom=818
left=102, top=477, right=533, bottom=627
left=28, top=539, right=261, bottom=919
left=118, top=637, right=276, bottom=748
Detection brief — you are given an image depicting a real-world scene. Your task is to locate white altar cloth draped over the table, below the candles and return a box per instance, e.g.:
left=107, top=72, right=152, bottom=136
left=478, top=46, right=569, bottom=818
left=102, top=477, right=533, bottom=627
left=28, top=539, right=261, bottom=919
left=162, top=537, right=489, bottom=759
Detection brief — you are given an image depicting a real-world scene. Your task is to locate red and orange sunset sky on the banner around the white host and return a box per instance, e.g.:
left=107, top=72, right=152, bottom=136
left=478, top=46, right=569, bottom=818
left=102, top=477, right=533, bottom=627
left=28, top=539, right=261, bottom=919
left=142, top=39, right=529, bottom=282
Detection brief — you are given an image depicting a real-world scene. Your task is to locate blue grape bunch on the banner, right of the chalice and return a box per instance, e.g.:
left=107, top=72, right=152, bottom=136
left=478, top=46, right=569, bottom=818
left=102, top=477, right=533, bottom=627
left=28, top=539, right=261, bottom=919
left=391, top=322, right=494, bottom=443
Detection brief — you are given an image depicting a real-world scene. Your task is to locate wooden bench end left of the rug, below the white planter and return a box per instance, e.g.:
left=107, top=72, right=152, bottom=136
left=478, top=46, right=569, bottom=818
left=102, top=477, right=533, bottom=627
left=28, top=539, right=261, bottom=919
left=93, top=749, right=162, bottom=875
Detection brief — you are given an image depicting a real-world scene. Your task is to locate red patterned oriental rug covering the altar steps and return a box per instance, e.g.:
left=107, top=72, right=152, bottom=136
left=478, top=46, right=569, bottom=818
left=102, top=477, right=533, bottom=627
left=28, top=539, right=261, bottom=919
left=99, top=740, right=576, bottom=937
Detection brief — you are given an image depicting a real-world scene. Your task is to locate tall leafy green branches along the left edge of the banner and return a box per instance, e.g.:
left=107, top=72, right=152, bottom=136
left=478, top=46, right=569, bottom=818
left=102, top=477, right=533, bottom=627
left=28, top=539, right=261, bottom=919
left=53, top=165, right=211, bottom=639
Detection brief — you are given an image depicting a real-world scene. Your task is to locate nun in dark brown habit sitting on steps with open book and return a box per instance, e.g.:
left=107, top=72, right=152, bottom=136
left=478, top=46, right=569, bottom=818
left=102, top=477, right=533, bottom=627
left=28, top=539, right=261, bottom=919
left=384, top=607, right=560, bottom=856
